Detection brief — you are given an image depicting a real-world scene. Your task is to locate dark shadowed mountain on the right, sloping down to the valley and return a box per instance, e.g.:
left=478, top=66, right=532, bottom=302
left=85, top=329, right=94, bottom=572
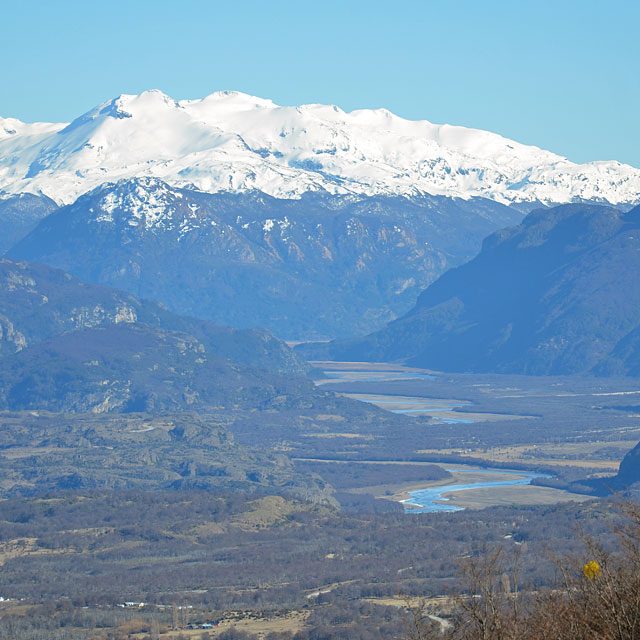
left=300, top=205, right=640, bottom=375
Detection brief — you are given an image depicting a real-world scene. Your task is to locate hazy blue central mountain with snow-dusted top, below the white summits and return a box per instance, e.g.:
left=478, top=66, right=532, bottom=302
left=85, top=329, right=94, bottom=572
left=8, top=178, right=522, bottom=339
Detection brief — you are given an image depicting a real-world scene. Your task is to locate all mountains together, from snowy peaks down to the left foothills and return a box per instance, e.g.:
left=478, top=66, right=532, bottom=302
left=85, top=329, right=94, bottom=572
left=0, top=91, right=640, bottom=503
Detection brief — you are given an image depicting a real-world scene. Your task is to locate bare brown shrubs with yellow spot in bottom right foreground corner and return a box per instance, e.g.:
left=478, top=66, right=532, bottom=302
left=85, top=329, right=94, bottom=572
left=407, top=502, right=640, bottom=640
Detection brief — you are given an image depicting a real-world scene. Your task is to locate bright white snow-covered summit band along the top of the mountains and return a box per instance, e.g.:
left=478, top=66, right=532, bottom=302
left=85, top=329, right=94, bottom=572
left=0, top=91, right=640, bottom=204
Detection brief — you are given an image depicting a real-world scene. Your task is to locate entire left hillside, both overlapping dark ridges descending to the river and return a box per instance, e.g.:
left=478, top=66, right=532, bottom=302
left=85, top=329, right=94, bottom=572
left=0, top=259, right=330, bottom=413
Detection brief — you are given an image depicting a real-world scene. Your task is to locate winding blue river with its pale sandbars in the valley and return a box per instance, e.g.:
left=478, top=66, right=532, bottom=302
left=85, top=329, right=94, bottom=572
left=315, top=362, right=604, bottom=513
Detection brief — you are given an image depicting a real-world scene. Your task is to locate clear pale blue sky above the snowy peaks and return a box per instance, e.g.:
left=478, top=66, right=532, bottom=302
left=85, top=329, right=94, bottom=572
left=5, top=0, right=640, bottom=167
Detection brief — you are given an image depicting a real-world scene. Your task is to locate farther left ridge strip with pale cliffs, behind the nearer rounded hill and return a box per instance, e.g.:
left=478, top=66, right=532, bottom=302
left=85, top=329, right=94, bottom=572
left=0, top=259, right=308, bottom=375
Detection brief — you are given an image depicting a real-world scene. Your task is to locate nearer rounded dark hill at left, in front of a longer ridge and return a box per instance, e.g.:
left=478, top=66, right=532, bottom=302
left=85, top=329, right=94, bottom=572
left=0, top=322, right=321, bottom=414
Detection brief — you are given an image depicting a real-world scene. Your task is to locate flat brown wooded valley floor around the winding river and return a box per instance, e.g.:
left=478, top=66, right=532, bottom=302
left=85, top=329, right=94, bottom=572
left=0, top=363, right=640, bottom=640
